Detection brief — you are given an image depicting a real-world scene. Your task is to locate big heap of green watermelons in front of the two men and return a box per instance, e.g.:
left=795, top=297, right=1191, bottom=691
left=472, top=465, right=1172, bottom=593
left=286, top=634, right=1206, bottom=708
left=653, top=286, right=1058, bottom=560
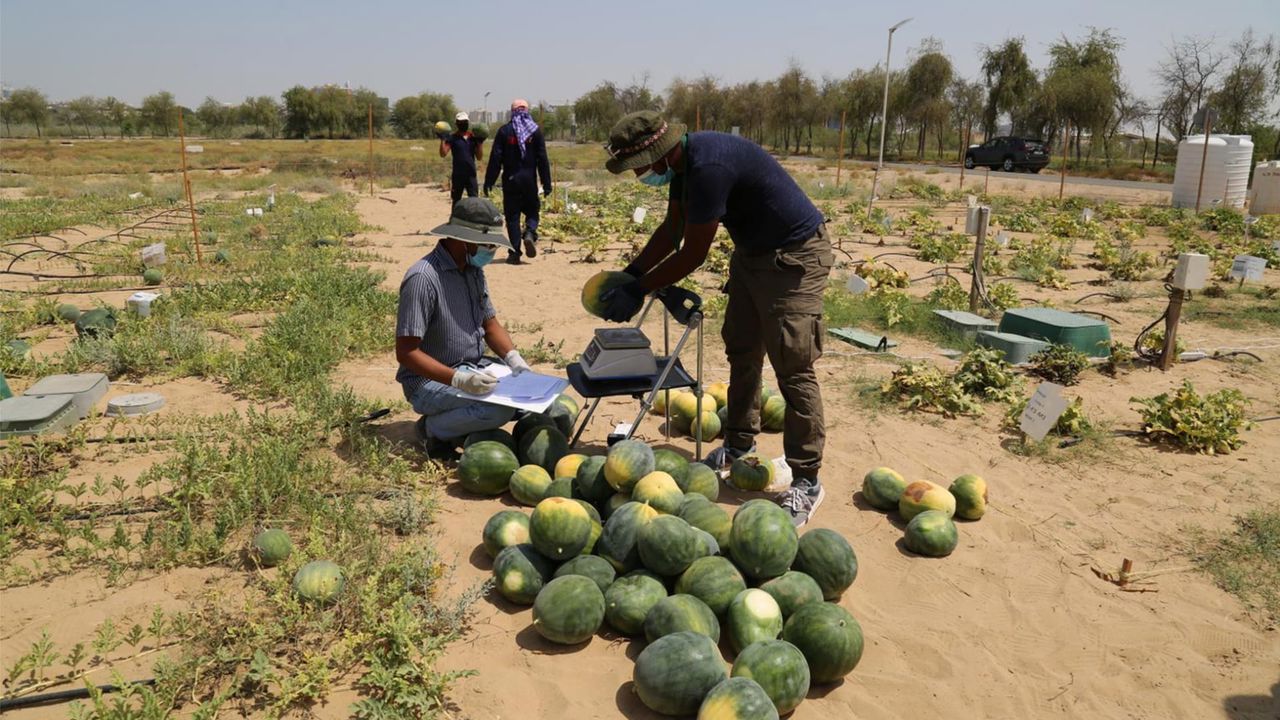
left=460, top=420, right=863, bottom=717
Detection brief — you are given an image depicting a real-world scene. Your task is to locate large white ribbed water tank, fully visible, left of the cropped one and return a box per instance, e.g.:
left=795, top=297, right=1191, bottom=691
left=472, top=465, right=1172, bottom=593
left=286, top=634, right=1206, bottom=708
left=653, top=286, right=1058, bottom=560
left=1174, top=135, right=1253, bottom=210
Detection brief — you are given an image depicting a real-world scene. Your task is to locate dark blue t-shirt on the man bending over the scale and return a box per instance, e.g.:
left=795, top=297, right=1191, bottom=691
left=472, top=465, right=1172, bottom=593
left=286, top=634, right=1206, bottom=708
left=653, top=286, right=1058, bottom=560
left=669, top=132, right=823, bottom=250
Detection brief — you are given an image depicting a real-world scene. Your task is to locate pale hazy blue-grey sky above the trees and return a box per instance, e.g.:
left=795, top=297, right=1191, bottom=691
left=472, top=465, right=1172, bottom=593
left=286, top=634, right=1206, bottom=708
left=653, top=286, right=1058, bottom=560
left=0, top=0, right=1280, bottom=109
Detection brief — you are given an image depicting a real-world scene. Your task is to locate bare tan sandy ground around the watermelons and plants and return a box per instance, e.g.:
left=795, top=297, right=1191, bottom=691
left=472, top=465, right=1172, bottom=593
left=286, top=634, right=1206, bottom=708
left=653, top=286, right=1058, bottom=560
left=0, top=168, right=1280, bottom=720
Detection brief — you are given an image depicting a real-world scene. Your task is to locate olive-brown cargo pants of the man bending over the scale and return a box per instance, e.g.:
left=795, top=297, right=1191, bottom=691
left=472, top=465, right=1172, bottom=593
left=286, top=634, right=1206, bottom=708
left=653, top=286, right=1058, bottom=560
left=721, top=225, right=836, bottom=478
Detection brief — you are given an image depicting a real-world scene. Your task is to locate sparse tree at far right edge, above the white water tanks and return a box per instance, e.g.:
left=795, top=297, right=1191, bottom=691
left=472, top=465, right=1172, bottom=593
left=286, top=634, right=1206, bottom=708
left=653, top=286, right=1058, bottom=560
left=1208, top=28, right=1280, bottom=133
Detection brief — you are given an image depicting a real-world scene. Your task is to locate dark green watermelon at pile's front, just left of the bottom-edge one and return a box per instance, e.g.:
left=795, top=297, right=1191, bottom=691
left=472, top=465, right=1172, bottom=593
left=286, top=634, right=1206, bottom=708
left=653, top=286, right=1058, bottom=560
left=632, top=633, right=727, bottom=716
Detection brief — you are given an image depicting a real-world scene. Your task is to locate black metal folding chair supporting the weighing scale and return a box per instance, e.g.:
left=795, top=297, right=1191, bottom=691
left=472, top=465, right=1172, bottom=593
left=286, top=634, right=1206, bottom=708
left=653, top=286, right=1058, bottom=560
left=567, top=287, right=703, bottom=460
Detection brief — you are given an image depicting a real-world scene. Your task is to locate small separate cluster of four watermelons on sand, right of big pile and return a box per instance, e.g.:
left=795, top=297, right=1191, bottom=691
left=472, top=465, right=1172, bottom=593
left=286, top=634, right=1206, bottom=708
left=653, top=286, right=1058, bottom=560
left=863, top=468, right=987, bottom=557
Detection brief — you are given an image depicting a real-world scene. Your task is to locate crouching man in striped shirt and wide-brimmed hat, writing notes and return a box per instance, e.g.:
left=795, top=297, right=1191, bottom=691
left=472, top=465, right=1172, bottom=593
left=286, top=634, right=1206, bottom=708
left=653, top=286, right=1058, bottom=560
left=396, top=197, right=529, bottom=459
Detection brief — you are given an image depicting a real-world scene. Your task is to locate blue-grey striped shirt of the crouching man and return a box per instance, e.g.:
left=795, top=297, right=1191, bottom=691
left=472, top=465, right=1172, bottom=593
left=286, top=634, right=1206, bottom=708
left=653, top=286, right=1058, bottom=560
left=396, top=243, right=497, bottom=397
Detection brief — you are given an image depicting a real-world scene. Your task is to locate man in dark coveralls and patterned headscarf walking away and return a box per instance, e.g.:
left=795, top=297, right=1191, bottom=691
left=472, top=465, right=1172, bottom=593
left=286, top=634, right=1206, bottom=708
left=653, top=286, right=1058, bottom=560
left=484, top=100, right=552, bottom=260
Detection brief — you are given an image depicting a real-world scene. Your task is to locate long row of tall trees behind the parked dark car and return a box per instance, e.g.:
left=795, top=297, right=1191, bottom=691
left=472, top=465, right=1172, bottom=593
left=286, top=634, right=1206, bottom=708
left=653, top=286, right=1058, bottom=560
left=573, top=28, right=1280, bottom=167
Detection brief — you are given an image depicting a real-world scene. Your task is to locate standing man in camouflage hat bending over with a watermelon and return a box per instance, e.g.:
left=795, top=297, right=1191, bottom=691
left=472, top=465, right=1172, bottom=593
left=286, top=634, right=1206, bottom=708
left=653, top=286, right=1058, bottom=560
left=602, top=110, right=835, bottom=527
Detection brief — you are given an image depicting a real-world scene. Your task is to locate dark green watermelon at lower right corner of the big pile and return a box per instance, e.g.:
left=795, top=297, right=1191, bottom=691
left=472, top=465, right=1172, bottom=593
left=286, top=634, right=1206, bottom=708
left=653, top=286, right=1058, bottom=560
left=782, top=602, right=863, bottom=685
